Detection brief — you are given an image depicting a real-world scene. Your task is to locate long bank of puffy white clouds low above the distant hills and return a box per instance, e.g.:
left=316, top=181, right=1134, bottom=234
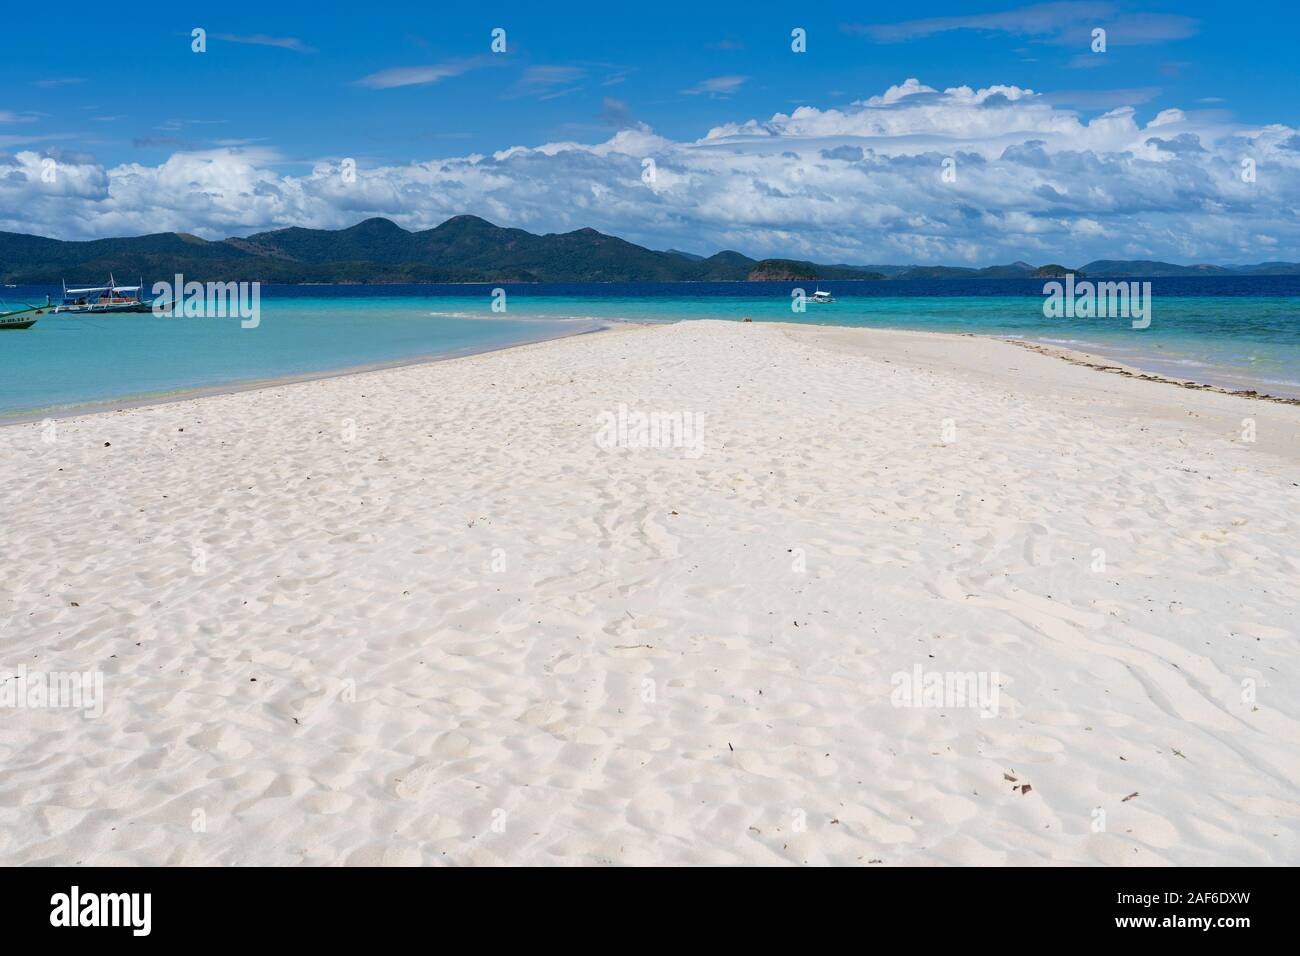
left=0, top=79, right=1300, bottom=264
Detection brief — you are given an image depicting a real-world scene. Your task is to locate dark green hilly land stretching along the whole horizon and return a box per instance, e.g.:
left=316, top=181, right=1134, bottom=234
left=0, top=216, right=1300, bottom=285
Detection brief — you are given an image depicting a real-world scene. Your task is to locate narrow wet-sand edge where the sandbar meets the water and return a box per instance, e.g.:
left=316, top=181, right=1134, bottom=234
left=0, top=319, right=1300, bottom=428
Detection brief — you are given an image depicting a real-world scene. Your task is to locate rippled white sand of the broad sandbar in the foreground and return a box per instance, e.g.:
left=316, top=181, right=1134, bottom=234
left=0, top=323, right=1300, bottom=865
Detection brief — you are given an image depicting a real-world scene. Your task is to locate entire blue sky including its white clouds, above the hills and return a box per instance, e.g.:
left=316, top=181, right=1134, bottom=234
left=0, top=0, right=1300, bottom=263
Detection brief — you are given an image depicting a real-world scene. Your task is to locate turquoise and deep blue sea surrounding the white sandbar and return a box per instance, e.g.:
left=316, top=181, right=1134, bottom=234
left=0, top=276, right=1300, bottom=419
